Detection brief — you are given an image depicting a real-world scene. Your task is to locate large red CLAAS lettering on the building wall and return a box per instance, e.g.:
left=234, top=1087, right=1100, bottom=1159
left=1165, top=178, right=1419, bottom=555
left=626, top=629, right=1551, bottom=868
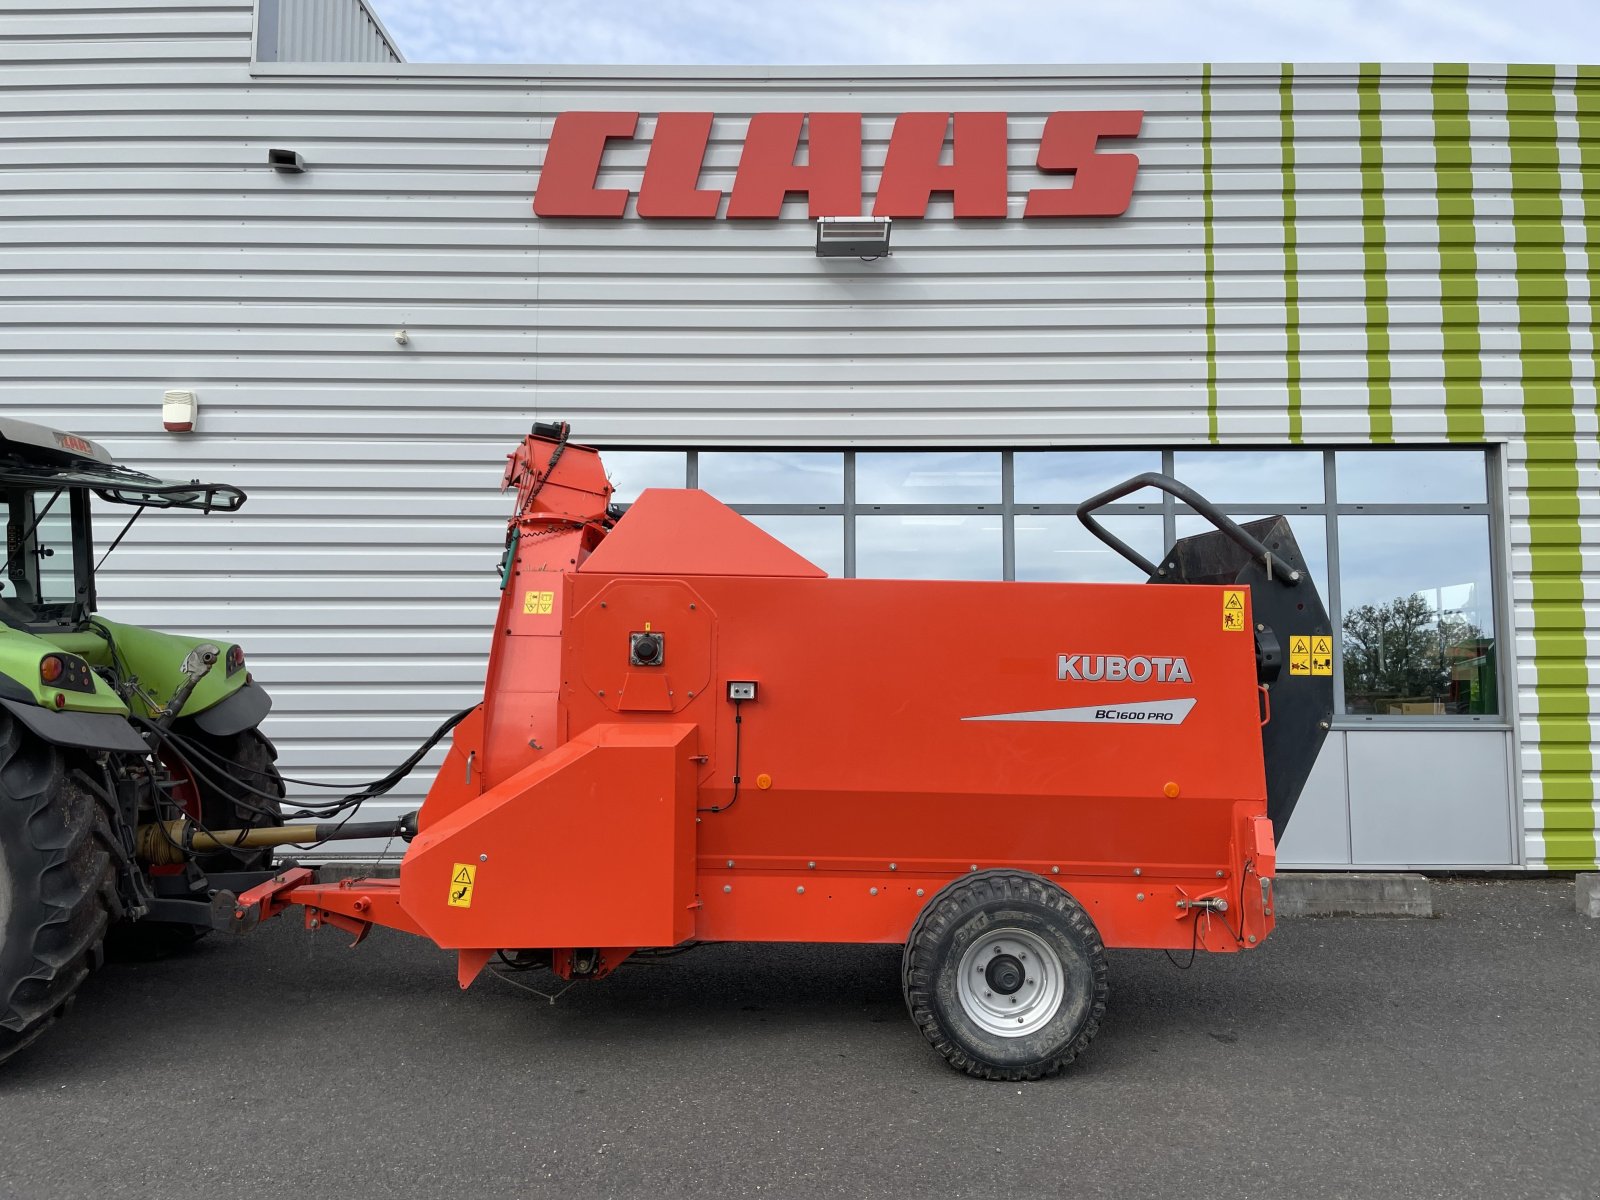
left=533, top=110, right=1144, bottom=221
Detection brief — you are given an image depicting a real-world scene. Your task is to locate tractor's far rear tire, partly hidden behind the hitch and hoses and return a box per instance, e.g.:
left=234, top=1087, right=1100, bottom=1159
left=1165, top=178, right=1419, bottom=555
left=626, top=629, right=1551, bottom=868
left=107, top=725, right=283, bottom=962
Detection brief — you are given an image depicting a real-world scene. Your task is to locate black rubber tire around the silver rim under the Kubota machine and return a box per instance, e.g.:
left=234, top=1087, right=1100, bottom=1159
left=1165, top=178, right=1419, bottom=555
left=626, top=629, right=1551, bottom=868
left=901, top=870, right=1110, bottom=1083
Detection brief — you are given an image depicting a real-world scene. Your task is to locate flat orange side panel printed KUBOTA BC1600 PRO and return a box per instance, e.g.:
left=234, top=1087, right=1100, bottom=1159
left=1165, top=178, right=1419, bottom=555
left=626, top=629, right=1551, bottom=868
left=563, top=573, right=1266, bottom=946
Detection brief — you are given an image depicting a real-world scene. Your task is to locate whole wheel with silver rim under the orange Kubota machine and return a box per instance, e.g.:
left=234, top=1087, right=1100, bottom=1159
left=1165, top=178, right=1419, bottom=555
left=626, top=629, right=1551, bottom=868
left=902, top=870, right=1107, bottom=1080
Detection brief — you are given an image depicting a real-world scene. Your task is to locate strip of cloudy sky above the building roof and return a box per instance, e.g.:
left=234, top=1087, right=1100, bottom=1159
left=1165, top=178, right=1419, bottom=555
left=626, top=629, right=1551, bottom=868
left=368, top=0, right=1600, bottom=66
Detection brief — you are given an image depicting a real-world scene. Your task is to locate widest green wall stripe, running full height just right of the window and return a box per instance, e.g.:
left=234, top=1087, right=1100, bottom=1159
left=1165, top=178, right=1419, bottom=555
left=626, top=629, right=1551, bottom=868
left=1506, top=67, right=1595, bottom=869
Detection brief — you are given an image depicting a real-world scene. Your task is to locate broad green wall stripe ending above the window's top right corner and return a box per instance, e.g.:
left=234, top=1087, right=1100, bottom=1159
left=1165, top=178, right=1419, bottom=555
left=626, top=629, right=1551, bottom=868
left=1434, top=62, right=1483, bottom=442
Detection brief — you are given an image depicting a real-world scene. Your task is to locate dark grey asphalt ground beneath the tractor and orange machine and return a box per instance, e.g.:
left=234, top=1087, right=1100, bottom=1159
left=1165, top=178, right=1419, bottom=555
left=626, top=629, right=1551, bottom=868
left=0, top=880, right=1600, bottom=1200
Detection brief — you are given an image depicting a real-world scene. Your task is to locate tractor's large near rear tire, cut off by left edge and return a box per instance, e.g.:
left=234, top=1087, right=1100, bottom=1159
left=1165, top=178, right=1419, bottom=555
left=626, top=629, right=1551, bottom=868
left=0, top=712, right=122, bottom=1062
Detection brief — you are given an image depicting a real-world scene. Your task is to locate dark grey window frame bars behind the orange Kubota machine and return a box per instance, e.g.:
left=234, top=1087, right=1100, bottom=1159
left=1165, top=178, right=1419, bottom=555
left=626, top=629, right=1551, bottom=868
left=600, top=443, right=1515, bottom=730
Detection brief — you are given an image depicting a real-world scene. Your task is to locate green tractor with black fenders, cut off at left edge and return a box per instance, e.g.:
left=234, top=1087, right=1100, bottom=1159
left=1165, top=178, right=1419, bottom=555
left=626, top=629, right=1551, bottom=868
left=0, top=418, right=288, bottom=1061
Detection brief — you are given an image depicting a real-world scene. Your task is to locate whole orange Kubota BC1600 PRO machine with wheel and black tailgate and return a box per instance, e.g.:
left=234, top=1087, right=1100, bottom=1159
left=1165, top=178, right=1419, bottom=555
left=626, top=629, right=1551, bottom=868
left=224, top=426, right=1331, bottom=1080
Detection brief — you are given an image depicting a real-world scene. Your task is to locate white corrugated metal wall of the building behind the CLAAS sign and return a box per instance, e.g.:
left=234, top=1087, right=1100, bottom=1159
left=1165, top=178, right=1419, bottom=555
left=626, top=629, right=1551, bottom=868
left=0, top=0, right=1600, bottom=862
